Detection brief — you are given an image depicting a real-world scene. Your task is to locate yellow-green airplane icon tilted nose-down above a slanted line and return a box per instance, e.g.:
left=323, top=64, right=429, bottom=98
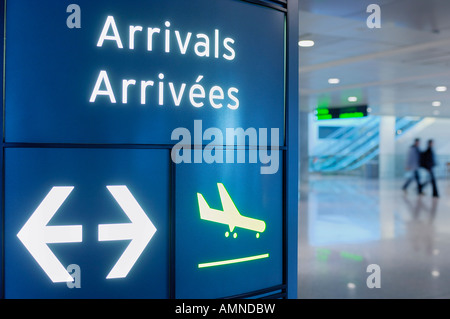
left=197, top=183, right=266, bottom=237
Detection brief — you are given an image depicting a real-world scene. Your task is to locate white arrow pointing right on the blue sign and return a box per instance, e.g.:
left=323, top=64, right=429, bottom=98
left=98, top=185, right=156, bottom=279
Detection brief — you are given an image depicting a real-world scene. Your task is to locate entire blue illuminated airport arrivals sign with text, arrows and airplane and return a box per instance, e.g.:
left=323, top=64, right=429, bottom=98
left=0, top=0, right=298, bottom=298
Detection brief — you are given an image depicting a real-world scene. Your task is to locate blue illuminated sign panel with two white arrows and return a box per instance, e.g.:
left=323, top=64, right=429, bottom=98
left=5, top=149, right=169, bottom=298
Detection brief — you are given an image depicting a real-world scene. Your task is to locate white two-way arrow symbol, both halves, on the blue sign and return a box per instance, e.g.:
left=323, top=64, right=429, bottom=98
left=17, top=185, right=156, bottom=282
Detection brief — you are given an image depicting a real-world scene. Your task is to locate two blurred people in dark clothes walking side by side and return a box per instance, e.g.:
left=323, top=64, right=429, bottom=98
left=402, top=138, right=439, bottom=197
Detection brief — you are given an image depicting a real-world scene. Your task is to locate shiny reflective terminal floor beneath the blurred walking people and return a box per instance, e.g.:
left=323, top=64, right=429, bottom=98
left=298, top=176, right=450, bottom=299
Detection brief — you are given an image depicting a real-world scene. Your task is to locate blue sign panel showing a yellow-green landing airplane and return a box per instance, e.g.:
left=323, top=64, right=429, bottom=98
left=176, top=154, right=283, bottom=298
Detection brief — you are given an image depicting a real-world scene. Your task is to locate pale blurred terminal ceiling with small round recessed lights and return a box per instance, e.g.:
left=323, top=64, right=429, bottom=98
left=299, top=0, right=450, bottom=117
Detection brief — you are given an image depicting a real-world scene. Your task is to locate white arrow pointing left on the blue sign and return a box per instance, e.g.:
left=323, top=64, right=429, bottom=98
left=17, top=186, right=82, bottom=282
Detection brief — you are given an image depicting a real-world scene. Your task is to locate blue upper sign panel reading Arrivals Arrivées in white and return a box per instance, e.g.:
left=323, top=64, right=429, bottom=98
left=5, top=0, right=284, bottom=144
